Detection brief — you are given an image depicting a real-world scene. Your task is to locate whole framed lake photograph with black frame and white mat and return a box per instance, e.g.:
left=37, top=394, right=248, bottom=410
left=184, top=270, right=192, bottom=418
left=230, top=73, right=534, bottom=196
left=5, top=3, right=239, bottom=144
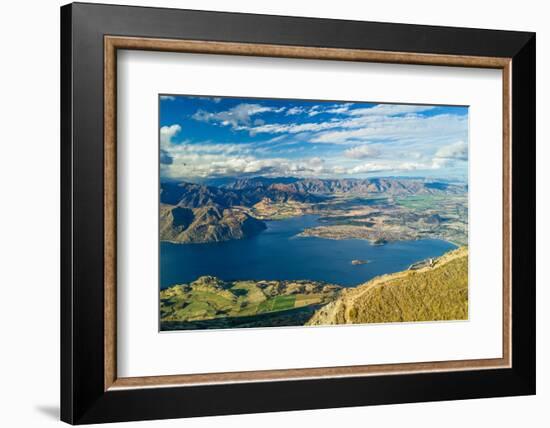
left=61, top=3, right=535, bottom=424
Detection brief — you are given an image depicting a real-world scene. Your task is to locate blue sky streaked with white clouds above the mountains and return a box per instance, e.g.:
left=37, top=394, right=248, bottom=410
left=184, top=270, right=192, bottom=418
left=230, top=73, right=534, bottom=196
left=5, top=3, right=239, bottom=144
left=159, top=95, right=468, bottom=181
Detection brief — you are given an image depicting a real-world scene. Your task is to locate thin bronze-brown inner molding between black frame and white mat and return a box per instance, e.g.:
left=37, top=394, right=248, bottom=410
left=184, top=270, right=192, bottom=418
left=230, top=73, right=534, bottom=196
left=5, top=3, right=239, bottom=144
left=103, top=36, right=512, bottom=391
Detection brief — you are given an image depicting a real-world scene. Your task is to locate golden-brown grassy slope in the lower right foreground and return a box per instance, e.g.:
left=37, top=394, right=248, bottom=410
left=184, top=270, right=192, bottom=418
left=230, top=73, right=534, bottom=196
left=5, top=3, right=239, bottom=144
left=307, top=247, right=468, bottom=325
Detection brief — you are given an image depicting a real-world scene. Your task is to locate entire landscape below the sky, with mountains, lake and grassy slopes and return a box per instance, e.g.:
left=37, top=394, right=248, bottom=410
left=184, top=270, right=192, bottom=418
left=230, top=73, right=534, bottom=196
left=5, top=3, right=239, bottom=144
left=159, top=177, right=468, bottom=331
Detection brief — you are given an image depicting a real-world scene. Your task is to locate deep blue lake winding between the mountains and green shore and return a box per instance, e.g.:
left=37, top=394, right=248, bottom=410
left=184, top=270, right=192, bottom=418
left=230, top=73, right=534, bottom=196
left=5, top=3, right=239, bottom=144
left=160, top=215, right=456, bottom=289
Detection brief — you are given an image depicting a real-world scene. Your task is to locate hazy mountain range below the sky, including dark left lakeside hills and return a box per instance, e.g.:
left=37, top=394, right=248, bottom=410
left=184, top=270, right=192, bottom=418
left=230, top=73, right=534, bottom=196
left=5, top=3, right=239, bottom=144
left=160, top=177, right=467, bottom=243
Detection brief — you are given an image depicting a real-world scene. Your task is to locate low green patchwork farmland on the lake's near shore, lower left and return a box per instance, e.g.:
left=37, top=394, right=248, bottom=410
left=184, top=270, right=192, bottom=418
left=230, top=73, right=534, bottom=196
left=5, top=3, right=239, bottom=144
left=160, top=276, right=340, bottom=330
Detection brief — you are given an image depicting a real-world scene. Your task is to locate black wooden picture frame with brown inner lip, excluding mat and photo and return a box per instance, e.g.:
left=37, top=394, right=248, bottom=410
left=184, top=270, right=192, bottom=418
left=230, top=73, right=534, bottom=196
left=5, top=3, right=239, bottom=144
left=61, top=3, right=535, bottom=424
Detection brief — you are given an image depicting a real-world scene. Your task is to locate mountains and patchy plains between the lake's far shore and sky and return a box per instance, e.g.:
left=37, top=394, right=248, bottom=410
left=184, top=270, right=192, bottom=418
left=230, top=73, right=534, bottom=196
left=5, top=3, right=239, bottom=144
left=160, top=178, right=468, bottom=245
